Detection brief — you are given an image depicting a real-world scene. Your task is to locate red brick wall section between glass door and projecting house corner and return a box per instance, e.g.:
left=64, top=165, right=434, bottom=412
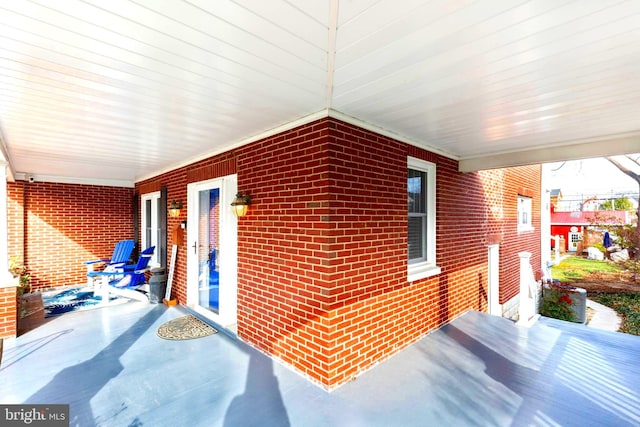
left=238, top=120, right=337, bottom=379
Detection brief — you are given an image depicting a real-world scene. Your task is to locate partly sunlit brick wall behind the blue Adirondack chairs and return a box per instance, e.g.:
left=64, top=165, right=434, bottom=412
left=7, top=181, right=133, bottom=289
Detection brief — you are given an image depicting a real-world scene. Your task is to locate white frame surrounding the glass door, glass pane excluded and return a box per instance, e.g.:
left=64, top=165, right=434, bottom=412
left=186, top=174, right=238, bottom=327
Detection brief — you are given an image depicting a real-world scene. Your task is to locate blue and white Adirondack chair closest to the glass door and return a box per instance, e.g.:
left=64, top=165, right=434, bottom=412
left=91, top=246, right=156, bottom=302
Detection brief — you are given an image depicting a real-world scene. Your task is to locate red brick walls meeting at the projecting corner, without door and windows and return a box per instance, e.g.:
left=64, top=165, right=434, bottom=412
left=136, top=119, right=540, bottom=387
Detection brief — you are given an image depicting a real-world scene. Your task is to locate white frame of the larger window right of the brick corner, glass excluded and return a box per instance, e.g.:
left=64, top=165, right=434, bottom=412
left=406, top=157, right=441, bottom=282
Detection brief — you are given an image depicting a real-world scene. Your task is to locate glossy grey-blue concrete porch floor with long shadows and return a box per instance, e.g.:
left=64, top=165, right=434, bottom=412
left=0, top=302, right=640, bottom=427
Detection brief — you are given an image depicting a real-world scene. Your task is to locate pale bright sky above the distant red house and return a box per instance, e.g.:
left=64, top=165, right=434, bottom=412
left=545, top=155, right=640, bottom=197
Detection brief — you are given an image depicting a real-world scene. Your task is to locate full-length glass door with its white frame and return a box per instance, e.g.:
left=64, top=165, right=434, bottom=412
left=187, top=175, right=237, bottom=329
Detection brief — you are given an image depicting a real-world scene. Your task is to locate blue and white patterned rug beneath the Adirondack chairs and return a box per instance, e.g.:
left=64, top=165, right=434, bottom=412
left=42, top=287, right=127, bottom=317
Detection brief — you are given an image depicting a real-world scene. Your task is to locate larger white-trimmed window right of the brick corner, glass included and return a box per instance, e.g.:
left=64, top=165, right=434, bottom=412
left=407, top=157, right=440, bottom=282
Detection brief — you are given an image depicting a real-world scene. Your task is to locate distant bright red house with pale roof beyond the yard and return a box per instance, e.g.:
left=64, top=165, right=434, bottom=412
left=551, top=210, right=630, bottom=253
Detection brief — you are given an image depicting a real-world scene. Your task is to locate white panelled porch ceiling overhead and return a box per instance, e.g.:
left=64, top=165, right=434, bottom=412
left=0, top=0, right=640, bottom=185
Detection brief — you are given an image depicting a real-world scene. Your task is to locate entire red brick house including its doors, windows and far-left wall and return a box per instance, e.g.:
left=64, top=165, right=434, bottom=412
left=3, top=118, right=546, bottom=389
